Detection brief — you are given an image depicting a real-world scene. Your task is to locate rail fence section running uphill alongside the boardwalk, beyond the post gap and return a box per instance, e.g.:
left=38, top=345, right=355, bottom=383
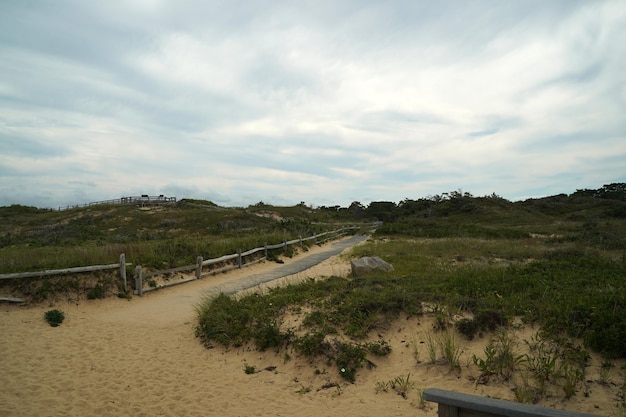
left=134, top=226, right=358, bottom=296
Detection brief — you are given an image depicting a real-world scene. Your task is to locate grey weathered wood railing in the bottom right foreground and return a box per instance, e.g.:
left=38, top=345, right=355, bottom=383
left=424, top=388, right=598, bottom=417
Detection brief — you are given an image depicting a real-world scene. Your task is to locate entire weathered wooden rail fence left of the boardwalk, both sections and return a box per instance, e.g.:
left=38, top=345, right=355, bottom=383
left=0, top=226, right=358, bottom=302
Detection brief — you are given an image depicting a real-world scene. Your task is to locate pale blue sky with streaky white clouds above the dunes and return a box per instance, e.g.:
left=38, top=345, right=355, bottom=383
left=0, top=0, right=626, bottom=208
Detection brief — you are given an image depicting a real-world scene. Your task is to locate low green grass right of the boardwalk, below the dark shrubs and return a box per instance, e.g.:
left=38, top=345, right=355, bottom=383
left=193, top=205, right=626, bottom=386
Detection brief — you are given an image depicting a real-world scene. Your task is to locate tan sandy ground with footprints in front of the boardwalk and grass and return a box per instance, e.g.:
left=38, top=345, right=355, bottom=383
left=0, top=237, right=624, bottom=417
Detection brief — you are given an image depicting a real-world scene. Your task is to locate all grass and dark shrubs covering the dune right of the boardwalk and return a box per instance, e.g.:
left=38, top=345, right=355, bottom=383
left=197, top=182, right=626, bottom=396
